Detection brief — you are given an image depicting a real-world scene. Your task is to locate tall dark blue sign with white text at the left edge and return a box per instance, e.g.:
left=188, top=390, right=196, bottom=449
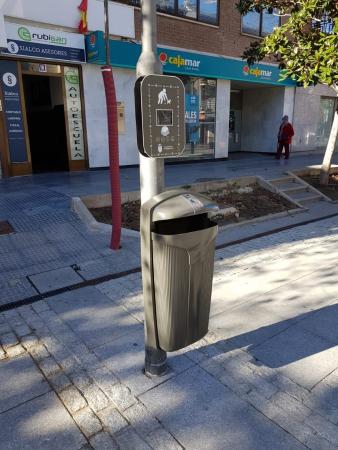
left=0, top=60, right=27, bottom=163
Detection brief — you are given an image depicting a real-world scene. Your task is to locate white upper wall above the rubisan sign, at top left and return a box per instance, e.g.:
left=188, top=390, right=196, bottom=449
left=0, top=0, right=135, bottom=46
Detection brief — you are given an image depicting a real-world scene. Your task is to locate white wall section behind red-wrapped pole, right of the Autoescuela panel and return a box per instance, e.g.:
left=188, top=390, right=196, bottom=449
left=83, top=64, right=139, bottom=167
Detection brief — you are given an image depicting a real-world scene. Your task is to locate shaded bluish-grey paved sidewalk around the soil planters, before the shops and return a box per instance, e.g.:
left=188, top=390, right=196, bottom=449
left=0, top=155, right=338, bottom=309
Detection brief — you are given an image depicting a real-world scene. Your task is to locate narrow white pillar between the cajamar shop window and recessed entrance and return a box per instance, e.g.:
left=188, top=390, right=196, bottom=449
left=215, top=80, right=231, bottom=158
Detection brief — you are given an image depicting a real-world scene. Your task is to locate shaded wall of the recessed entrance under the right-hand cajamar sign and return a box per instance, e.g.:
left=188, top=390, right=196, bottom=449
left=241, top=86, right=285, bottom=153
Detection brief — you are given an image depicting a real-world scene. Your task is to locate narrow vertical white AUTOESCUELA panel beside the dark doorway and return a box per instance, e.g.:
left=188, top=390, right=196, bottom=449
left=64, top=67, right=85, bottom=161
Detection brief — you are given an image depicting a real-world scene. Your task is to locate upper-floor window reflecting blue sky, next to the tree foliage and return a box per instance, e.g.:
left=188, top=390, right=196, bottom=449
left=242, top=10, right=280, bottom=36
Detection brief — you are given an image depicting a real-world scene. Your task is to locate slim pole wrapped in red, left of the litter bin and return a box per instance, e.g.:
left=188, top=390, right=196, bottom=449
left=101, top=66, right=121, bottom=250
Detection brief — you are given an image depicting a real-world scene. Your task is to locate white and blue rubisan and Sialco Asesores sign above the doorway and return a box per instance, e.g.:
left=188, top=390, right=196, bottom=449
left=3, top=22, right=86, bottom=62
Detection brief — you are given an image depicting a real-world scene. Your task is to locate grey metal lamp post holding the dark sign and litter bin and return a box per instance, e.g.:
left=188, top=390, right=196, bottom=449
left=136, top=0, right=167, bottom=375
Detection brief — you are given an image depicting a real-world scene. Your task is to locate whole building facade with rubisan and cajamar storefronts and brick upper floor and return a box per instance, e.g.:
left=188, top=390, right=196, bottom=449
left=0, top=0, right=336, bottom=176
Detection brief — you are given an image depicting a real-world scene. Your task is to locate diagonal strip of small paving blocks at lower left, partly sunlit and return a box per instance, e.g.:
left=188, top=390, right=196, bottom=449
left=0, top=302, right=182, bottom=450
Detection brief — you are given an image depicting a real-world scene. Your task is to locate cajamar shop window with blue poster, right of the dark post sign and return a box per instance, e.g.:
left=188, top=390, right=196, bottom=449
left=180, top=76, right=216, bottom=158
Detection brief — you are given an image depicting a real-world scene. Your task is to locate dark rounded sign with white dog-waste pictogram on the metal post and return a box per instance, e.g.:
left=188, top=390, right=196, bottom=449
left=135, top=75, right=185, bottom=158
